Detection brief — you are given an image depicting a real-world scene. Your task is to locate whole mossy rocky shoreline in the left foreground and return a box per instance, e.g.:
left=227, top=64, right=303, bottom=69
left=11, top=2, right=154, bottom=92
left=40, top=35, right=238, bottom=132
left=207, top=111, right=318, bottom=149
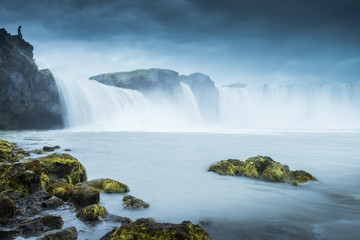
left=0, top=140, right=210, bottom=240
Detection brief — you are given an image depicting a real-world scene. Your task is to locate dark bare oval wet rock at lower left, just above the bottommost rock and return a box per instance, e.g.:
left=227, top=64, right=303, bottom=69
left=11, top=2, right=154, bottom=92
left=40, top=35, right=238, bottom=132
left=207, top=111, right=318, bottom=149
left=19, top=215, right=64, bottom=234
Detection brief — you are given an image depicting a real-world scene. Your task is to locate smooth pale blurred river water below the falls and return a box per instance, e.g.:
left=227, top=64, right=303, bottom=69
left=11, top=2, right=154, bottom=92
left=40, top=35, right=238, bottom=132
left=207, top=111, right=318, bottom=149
left=0, top=130, right=360, bottom=239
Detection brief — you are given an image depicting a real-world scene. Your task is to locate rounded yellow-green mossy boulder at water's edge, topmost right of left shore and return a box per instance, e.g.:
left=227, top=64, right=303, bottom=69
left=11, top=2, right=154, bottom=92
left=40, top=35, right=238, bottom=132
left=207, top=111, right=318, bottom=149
left=39, top=153, right=87, bottom=184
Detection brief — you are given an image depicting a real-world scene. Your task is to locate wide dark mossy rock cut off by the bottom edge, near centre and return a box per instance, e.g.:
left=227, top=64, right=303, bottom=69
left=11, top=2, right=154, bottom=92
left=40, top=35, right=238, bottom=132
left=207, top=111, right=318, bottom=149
left=101, top=218, right=210, bottom=240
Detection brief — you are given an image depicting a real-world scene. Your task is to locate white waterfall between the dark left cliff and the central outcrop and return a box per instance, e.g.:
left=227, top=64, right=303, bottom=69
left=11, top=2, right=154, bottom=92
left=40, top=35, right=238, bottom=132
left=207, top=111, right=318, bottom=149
left=56, top=77, right=201, bottom=131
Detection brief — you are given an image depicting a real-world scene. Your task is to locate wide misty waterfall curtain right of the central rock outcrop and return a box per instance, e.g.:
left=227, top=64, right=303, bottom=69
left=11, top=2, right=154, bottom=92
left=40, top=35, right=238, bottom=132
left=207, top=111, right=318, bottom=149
left=219, top=82, right=360, bottom=130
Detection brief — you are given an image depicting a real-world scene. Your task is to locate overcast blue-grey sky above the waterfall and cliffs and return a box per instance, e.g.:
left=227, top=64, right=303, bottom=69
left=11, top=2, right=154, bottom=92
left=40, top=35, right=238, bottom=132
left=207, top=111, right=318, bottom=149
left=0, top=0, right=360, bottom=85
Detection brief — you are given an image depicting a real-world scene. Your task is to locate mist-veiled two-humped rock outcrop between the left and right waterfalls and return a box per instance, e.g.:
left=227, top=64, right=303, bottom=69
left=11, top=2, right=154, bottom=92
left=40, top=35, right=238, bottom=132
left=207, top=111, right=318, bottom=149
left=90, top=68, right=219, bottom=121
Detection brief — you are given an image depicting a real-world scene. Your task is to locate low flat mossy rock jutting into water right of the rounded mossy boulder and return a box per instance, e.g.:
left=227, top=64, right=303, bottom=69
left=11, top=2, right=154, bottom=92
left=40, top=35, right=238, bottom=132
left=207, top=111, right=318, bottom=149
left=78, top=178, right=130, bottom=193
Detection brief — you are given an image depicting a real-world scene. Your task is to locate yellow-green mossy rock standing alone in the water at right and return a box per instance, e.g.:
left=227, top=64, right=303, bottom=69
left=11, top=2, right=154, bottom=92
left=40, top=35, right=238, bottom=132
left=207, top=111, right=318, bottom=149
left=209, top=156, right=317, bottom=185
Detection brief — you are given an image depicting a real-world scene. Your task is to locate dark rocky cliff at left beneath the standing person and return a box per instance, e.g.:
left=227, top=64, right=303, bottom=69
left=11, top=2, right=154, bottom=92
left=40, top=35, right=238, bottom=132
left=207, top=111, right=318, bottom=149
left=0, top=28, right=63, bottom=130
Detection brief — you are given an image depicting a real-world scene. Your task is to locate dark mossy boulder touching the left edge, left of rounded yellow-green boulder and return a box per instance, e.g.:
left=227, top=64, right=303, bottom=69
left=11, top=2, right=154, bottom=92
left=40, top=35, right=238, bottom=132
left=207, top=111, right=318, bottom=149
left=0, top=160, right=49, bottom=195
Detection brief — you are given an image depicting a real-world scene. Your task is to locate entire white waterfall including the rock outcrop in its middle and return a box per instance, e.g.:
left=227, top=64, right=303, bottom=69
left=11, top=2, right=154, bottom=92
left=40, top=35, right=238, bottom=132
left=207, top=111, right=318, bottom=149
left=53, top=69, right=360, bottom=132
